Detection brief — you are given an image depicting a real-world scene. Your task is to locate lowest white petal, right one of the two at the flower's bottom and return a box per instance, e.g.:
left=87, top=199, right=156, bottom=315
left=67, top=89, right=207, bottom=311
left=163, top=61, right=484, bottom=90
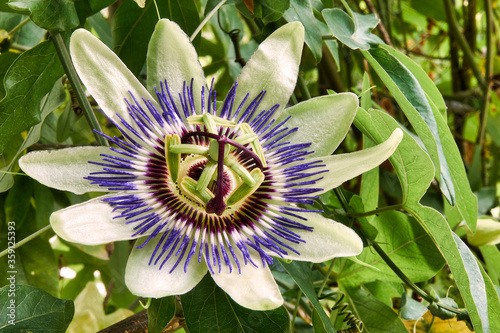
left=212, top=249, right=283, bottom=310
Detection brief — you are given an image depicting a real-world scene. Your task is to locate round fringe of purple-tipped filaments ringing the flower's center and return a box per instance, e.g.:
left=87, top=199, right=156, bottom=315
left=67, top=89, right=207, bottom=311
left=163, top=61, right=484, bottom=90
left=87, top=81, right=326, bottom=273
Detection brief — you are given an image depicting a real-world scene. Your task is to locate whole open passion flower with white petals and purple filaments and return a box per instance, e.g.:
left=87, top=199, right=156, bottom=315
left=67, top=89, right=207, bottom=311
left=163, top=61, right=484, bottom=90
left=19, top=20, right=402, bottom=310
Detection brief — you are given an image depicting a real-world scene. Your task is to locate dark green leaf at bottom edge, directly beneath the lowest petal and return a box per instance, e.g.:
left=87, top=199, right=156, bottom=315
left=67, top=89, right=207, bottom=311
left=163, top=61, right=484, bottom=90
left=181, top=274, right=290, bottom=333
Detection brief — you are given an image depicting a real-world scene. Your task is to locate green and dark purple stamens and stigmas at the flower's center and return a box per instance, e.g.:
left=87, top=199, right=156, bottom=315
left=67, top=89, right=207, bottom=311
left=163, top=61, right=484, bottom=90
left=165, top=113, right=267, bottom=216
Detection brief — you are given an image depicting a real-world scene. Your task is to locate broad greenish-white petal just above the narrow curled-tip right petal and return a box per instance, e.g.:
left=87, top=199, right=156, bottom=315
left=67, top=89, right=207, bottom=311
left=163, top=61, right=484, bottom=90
left=277, top=93, right=359, bottom=157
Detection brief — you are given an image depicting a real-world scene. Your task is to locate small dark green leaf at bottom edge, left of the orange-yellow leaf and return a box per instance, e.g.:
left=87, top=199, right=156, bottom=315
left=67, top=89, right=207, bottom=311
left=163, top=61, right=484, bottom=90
left=347, top=288, right=408, bottom=333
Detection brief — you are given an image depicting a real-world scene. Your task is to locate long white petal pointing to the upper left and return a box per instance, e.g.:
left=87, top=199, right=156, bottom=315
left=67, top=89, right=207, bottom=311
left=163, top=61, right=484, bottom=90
left=69, top=29, right=161, bottom=127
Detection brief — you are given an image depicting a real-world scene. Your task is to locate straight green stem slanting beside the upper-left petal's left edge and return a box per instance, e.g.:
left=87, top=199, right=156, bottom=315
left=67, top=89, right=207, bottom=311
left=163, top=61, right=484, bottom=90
left=50, top=30, right=108, bottom=146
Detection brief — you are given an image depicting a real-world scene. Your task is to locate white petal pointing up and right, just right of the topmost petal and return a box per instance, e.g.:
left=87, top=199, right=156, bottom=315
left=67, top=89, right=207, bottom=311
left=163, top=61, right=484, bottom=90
left=234, top=22, right=304, bottom=122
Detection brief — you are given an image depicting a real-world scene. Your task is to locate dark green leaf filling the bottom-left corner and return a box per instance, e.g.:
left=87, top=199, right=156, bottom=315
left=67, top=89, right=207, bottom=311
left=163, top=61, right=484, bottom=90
left=0, top=285, right=75, bottom=333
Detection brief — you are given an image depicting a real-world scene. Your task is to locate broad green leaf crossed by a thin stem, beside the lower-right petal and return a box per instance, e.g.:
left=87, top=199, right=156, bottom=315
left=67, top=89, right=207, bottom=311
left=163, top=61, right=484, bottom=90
left=338, top=211, right=444, bottom=286
